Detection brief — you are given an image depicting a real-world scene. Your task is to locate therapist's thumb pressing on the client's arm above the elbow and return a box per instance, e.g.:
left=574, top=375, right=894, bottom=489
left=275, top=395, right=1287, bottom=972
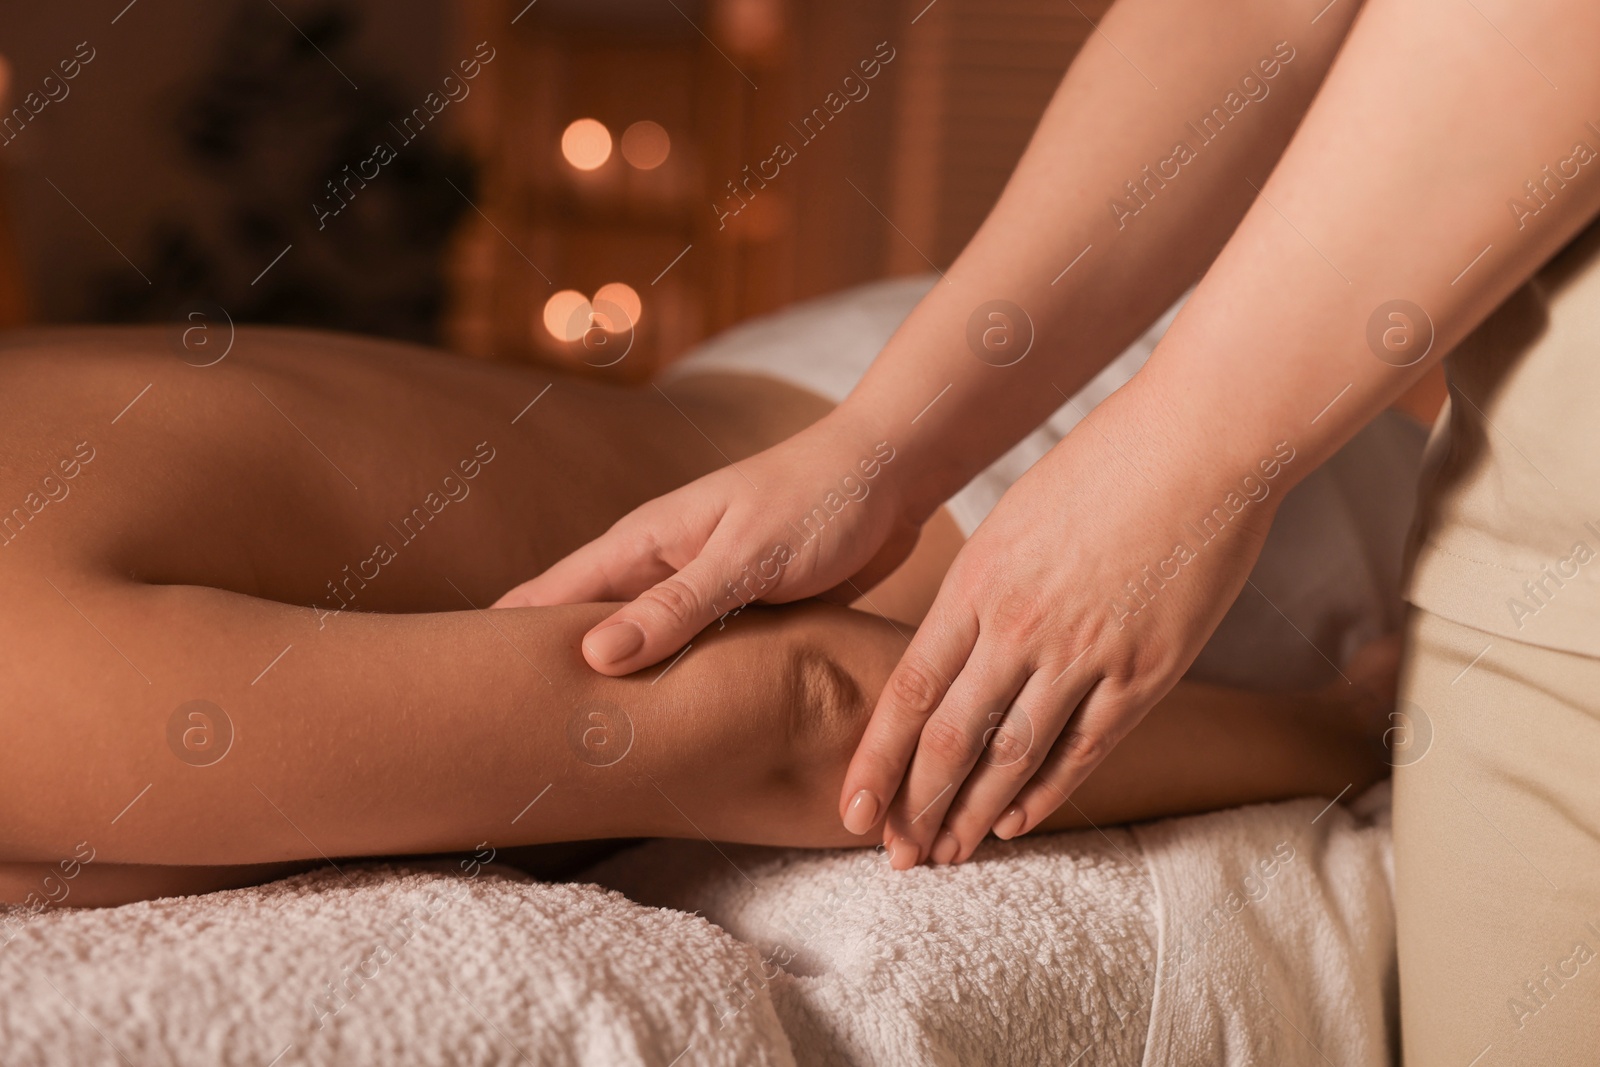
left=582, top=557, right=738, bottom=677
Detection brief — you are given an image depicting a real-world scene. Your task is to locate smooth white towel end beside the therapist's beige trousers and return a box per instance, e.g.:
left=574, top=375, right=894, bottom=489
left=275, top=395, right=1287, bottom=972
left=1134, top=782, right=1400, bottom=1067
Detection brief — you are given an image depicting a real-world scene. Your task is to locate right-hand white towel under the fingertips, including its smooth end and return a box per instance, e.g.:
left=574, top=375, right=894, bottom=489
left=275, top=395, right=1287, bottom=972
left=590, top=784, right=1395, bottom=1067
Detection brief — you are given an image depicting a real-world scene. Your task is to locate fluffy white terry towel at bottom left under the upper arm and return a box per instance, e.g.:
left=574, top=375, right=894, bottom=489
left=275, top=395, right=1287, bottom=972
left=0, top=862, right=794, bottom=1067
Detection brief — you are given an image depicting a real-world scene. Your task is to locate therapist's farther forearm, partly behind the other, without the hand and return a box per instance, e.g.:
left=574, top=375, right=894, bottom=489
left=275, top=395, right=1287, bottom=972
left=838, top=0, right=1358, bottom=512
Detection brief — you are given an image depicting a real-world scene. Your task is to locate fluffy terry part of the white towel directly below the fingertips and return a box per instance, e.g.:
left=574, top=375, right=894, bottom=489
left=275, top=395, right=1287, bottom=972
left=590, top=829, right=1157, bottom=1065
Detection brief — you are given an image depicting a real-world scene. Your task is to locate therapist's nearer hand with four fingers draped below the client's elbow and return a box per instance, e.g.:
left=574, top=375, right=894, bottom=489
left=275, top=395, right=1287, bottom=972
left=840, top=379, right=1280, bottom=869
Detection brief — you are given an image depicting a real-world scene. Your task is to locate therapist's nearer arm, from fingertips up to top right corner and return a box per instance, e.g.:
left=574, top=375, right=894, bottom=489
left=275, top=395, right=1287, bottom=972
left=864, top=0, right=1600, bottom=856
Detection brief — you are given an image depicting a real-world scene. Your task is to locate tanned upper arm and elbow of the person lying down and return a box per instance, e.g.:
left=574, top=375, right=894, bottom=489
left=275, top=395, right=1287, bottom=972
left=0, top=585, right=901, bottom=864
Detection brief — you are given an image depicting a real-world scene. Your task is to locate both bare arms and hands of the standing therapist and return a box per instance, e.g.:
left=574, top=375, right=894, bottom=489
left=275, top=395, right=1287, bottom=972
left=502, top=0, right=1600, bottom=865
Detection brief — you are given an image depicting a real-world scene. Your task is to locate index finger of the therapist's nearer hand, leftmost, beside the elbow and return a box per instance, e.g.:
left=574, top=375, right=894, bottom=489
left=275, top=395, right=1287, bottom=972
left=838, top=600, right=978, bottom=844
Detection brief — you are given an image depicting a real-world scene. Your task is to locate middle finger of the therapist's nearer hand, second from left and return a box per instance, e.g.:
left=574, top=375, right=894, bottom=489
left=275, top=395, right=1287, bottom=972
left=883, top=633, right=1029, bottom=862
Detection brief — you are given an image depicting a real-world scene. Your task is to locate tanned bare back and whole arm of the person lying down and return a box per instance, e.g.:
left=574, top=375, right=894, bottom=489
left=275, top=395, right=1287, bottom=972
left=0, top=330, right=1394, bottom=905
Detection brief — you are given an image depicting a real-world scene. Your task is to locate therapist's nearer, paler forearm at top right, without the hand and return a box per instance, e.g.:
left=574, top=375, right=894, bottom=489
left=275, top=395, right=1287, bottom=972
left=1126, top=0, right=1600, bottom=483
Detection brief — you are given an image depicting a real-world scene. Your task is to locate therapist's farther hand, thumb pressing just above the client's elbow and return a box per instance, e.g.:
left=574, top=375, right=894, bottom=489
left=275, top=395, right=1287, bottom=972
left=494, top=411, right=920, bottom=677
